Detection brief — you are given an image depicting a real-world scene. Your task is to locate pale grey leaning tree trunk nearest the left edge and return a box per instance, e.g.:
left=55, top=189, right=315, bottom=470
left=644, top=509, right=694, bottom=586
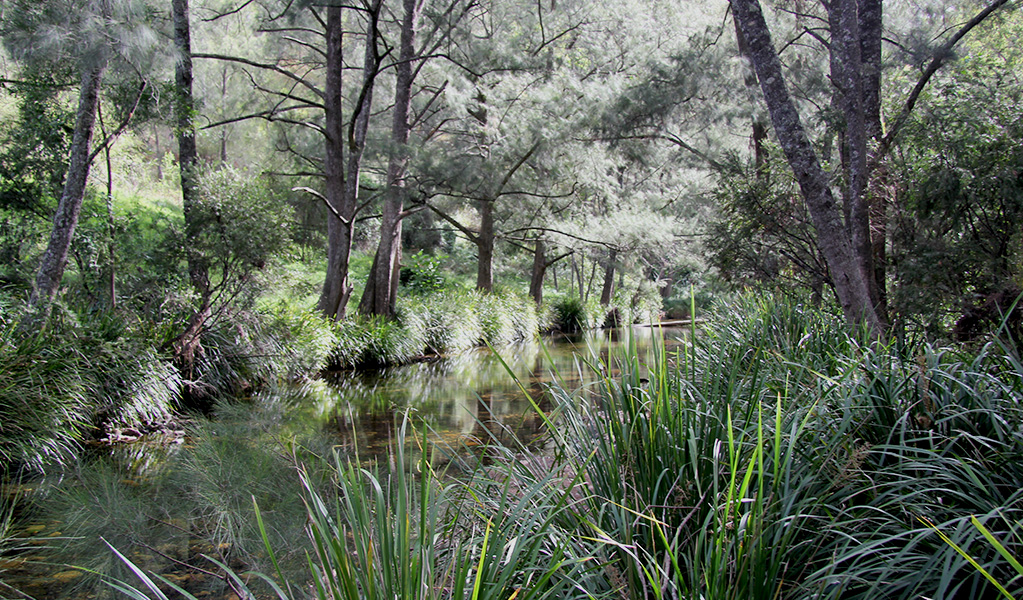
left=29, top=60, right=106, bottom=322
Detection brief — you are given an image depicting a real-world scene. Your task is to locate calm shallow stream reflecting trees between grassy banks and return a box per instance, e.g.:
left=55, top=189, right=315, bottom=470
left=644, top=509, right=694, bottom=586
left=0, top=328, right=683, bottom=599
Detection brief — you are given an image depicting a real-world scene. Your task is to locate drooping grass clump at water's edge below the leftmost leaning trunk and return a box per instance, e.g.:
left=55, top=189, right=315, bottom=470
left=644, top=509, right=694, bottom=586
left=0, top=306, right=181, bottom=471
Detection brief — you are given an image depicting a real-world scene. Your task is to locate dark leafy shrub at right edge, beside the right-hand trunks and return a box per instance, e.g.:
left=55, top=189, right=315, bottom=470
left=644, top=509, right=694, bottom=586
left=892, top=44, right=1023, bottom=338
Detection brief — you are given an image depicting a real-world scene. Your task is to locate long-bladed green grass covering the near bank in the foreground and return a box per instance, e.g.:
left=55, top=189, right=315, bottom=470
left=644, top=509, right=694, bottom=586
left=56, top=296, right=1023, bottom=599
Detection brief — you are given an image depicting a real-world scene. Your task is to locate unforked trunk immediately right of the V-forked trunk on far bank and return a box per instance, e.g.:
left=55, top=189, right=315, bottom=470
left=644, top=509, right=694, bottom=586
left=359, top=0, right=420, bottom=316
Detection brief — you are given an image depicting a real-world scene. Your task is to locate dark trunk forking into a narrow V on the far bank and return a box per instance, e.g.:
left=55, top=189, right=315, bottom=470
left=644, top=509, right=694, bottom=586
left=317, top=0, right=380, bottom=321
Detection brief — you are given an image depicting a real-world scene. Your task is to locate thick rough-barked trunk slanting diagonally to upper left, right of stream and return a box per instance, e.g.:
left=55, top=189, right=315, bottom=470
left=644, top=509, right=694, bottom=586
left=731, top=0, right=884, bottom=336
